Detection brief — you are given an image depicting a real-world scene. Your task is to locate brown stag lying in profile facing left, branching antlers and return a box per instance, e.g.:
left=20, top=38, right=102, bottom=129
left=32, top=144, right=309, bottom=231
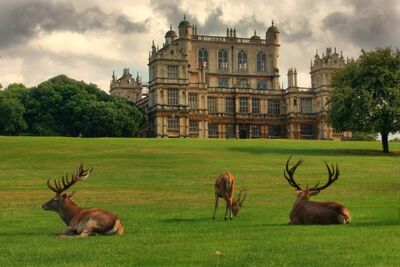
left=42, top=164, right=124, bottom=237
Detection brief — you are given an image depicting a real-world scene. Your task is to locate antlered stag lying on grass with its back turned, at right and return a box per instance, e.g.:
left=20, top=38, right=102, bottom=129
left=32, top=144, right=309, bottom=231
left=283, top=156, right=351, bottom=224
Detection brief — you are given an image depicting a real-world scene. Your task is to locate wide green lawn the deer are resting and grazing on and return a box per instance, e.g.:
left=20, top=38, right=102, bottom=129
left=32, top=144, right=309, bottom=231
left=0, top=137, right=400, bottom=266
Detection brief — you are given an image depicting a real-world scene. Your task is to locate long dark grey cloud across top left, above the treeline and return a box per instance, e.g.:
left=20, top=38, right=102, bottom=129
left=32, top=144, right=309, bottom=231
left=0, top=0, right=146, bottom=47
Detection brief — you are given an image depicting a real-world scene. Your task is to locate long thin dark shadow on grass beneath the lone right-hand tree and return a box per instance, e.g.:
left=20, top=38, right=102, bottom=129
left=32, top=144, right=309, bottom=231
left=228, top=147, right=400, bottom=157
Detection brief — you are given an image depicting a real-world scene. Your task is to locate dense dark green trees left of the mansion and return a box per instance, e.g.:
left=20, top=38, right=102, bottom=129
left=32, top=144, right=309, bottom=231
left=0, top=75, right=144, bottom=137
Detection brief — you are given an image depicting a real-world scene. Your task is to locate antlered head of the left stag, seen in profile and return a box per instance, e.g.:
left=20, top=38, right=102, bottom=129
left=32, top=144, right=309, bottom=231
left=42, top=164, right=93, bottom=211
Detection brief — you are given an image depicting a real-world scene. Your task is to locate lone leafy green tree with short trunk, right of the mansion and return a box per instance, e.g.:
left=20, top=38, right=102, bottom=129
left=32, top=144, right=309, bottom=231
left=328, top=48, right=400, bottom=153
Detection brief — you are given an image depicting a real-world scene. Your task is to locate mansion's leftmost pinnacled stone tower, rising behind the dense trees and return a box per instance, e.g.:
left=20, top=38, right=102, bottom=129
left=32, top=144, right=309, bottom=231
left=110, top=68, right=143, bottom=102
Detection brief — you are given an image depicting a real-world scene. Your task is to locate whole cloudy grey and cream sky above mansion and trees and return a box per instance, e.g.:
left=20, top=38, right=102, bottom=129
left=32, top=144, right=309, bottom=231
left=0, top=0, right=400, bottom=91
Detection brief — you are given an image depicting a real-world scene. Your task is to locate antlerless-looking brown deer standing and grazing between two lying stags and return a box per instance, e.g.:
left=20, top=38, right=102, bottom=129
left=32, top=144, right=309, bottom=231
left=213, top=172, right=247, bottom=220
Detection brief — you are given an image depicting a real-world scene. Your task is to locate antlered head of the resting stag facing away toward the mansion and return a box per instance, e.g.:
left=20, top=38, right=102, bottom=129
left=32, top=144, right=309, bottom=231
left=283, top=156, right=339, bottom=200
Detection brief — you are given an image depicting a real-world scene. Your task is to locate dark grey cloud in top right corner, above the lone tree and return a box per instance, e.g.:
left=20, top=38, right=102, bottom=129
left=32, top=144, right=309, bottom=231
left=323, top=0, right=400, bottom=49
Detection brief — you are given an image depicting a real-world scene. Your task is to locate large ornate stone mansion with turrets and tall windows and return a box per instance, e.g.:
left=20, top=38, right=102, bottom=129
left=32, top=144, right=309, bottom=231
left=110, top=16, right=346, bottom=139
